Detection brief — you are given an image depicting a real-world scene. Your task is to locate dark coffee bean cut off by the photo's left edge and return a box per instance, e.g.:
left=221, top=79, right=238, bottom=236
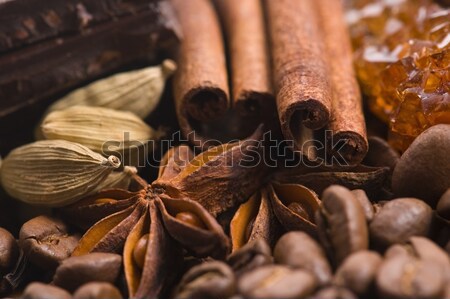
left=0, top=227, right=19, bottom=278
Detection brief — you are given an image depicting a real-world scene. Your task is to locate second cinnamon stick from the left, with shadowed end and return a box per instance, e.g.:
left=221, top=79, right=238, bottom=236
left=214, top=0, right=275, bottom=120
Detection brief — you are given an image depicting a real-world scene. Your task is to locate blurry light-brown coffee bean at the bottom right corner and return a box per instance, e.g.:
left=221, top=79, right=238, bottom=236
left=376, top=255, right=446, bottom=299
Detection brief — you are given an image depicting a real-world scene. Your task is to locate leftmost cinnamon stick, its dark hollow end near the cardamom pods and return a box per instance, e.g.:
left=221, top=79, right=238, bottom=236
left=171, top=0, right=230, bottom=145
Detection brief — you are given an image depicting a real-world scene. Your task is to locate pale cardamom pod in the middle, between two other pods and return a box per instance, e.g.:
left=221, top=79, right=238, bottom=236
left=41, top=106, right=161, bottom=154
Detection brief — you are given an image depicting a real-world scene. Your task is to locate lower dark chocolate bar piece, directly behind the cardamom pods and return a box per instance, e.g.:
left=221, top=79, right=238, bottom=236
left=0, top=1, right=178, bottom=118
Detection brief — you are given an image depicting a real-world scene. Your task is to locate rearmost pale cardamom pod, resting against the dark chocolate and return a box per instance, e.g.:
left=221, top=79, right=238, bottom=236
left=48, top=60, right=176, bottom=118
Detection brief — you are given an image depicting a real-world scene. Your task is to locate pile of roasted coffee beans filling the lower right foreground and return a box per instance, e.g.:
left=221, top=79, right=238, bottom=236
left=173, top=185, right=450, bottom=299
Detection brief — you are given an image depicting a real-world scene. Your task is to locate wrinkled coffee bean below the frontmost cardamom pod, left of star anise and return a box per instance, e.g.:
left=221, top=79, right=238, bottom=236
left=19, top=216, right=79, bottom=270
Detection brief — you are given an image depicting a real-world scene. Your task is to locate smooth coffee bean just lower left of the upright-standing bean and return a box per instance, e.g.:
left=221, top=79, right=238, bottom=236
left=274, top=231, right=332, bottom=285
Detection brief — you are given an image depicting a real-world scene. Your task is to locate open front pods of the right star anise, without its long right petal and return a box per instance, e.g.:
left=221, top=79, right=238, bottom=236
left=230, top=181, right=320, bottom=251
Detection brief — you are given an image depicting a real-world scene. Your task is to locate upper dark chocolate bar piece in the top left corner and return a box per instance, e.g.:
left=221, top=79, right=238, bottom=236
left=0, top=0, right=160, bottom=53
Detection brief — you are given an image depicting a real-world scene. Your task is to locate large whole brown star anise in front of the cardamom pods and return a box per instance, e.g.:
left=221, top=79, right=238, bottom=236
left=63, top=128, right=266, bottom=298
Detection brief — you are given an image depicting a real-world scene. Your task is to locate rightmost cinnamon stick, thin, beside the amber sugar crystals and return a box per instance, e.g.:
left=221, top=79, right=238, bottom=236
left=316, top=0, right=368, bottom=165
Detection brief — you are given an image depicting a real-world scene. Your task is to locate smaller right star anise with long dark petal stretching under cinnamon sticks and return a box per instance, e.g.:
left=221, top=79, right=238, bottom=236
left=230, top=165, right=389, bottom=251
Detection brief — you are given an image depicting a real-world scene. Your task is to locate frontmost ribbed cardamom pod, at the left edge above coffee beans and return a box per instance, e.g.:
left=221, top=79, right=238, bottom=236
left=0, top=140, right=121, bottom=207
